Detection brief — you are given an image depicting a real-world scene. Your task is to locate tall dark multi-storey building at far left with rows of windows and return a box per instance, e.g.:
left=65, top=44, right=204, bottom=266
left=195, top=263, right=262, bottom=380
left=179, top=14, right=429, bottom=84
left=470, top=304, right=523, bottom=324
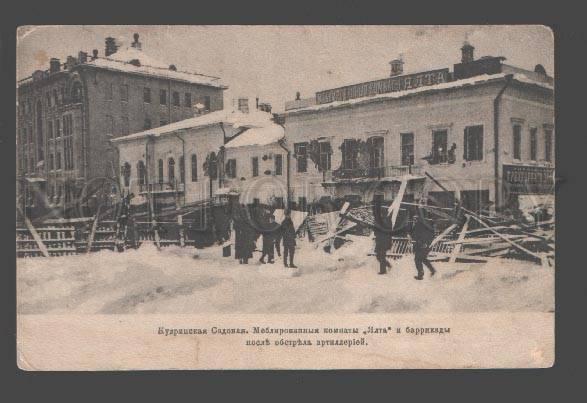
left=17, top=34, right=227, bottom=219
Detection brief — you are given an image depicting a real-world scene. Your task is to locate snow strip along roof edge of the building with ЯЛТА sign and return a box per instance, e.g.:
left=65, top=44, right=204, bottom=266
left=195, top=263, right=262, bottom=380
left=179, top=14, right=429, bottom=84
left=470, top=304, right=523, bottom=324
left=286, top=73, right=554, bottom=115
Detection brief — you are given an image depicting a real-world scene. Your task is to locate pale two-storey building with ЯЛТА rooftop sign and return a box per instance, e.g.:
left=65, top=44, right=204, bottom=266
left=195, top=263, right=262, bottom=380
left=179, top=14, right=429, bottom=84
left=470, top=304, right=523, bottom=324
left=284, top=43, right=554, bottom=216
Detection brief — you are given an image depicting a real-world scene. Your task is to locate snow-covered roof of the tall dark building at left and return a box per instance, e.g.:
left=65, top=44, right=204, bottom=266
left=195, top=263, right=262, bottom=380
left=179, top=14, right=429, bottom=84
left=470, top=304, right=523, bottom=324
left=80, top=47, right=228, bottom=88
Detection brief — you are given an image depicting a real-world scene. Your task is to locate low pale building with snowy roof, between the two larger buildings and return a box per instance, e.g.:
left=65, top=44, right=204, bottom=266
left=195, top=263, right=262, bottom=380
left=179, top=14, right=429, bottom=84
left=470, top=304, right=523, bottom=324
left=112, top=102, right=286, bottom=215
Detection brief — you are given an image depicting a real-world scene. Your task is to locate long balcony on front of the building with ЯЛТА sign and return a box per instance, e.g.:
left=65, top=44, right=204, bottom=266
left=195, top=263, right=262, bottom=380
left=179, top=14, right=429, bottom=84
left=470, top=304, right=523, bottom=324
left=324, top=165, right=422, bottom=184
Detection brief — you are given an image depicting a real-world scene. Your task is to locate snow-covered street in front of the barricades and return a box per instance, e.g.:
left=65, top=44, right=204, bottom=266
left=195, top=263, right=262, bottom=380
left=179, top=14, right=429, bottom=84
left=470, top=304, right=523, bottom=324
left=17, top=237, right=554, bottom=314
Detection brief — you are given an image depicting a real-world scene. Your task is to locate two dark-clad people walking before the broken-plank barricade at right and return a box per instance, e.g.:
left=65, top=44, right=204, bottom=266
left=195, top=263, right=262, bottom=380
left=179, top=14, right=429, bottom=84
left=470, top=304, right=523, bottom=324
left=373, top=199, right=436, bottom=280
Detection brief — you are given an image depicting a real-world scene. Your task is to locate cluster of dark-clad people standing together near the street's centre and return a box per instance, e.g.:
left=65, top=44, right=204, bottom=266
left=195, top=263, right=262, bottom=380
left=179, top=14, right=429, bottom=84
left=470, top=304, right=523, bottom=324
left=233, top=208, right=297, bottom=268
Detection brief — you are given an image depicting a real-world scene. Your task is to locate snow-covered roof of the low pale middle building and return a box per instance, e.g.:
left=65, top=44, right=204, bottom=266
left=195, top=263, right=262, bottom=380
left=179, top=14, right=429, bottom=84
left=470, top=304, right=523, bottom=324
left=111, top=109, right=281, bottom=143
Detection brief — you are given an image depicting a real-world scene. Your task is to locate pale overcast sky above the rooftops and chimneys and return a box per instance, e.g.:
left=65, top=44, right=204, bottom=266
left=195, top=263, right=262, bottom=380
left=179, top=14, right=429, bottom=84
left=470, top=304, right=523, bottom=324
left=17, top=25, right=554, bottom=111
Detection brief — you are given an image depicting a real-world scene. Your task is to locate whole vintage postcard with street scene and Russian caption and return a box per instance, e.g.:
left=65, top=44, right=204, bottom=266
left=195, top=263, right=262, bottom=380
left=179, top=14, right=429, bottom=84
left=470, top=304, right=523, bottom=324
left=15, top=25, right=555, bottom=371
